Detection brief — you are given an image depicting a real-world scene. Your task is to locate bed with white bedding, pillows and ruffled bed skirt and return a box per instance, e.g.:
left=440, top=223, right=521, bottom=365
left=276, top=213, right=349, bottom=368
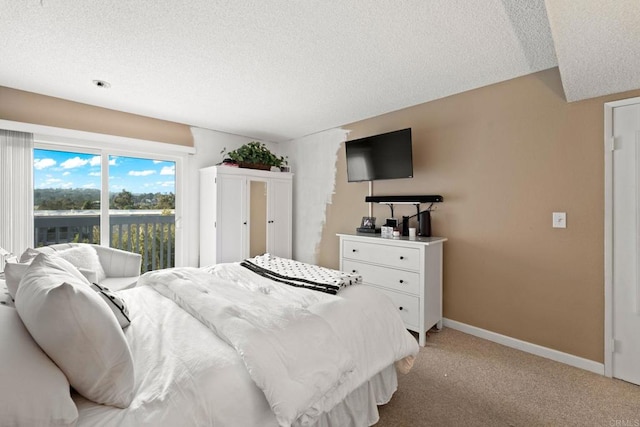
left=0, top=254, right=418, bottom=427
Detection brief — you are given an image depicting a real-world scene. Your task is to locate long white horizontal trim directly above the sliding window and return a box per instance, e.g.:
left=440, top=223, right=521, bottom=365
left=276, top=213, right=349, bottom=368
left=0, top=120, right=196, bottom=156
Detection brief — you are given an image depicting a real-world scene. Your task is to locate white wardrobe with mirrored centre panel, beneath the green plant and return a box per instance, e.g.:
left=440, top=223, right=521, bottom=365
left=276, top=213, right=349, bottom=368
left=200, top=166, right=293, bottom=266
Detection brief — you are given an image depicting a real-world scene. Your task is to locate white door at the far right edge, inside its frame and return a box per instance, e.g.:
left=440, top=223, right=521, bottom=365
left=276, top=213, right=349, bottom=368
left=611, top=104, right=640, bottom=384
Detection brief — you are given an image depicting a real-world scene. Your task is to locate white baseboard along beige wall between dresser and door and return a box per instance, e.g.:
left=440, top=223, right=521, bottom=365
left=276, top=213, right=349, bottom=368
left=443, top=318, right=604, bottom=375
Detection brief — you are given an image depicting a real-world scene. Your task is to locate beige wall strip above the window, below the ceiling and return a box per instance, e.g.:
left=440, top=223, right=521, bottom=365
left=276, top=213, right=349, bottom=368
left=0, top=86, right=193, bottom=147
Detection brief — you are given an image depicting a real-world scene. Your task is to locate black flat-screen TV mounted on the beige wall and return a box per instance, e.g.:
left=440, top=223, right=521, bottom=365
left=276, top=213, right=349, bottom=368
left=345, top=128, right=413, bottom=182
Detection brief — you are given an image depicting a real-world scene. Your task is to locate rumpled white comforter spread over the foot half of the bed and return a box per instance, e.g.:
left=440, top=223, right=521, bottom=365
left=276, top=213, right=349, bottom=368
left=139, top=263, right=418, bottom=426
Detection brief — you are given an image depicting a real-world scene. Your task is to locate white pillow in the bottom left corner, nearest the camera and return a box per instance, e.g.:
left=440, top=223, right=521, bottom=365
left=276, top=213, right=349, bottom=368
left=0, top=307, right=78, bottom=426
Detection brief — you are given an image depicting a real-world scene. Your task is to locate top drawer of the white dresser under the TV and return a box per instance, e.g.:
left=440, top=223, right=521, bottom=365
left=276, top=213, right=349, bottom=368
left=342, top=240, right=420, bottom=270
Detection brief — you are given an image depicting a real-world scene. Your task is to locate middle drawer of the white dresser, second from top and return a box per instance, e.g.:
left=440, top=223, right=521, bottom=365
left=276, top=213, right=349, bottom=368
left=342, top=259, right=420, bottom=295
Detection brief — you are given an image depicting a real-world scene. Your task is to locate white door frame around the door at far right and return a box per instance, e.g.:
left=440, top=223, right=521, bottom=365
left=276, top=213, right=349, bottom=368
left=604, top=97, right=640, bottom=377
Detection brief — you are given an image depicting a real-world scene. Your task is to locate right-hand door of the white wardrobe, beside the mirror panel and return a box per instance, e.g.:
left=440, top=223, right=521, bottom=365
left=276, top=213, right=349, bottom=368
left=267, top=179, right=293, bottom=258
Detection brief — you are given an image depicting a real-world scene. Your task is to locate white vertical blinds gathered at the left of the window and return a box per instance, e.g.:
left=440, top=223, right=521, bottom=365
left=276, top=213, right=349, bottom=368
left=0, top=129, right=33, bottom=271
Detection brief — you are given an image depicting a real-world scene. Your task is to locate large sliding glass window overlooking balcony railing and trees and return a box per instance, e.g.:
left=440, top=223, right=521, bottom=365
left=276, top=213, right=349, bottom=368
left=33, top=143, right=180, bottom=272
